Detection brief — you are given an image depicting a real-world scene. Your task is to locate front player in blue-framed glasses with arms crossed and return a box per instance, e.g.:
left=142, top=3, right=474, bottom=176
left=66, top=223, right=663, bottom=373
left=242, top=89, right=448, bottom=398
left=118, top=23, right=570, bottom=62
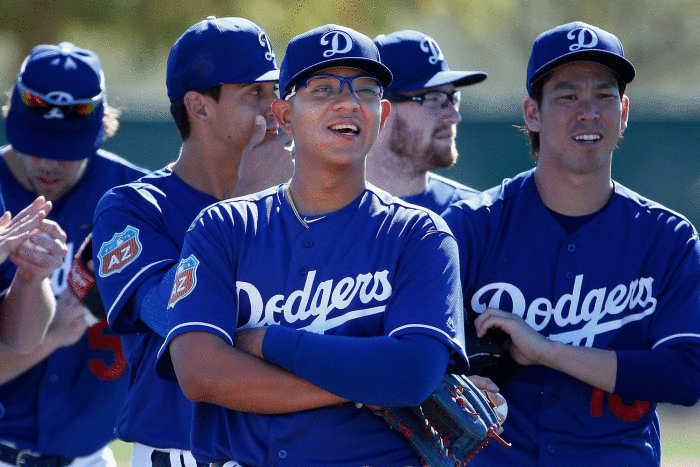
left=158, top=24, right=466, bottom=466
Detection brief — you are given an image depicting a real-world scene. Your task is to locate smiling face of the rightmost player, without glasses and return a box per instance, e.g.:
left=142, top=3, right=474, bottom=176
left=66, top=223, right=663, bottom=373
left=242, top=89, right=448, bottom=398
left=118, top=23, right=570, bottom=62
left=523, top=61, right=629, bottom=177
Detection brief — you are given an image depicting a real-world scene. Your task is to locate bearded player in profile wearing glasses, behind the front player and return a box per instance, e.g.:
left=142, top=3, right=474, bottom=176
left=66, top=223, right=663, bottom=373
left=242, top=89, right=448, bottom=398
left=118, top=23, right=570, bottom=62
left=367, top=30, right=486, bottom=214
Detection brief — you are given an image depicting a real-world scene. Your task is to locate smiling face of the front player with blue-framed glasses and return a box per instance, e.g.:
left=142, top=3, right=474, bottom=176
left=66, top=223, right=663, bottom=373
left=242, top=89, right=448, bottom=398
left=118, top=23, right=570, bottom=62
left=273, top=67, right=390, bottom=173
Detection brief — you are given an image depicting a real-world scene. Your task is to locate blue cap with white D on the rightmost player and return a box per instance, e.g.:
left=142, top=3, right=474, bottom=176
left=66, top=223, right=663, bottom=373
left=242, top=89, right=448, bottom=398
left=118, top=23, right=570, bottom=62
left=526, top=21, right=635, bottom=94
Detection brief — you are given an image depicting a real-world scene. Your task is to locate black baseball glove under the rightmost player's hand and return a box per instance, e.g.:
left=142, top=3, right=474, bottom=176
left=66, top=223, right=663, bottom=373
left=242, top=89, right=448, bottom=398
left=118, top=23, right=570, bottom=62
left=464, top=323, right=522, bottom=386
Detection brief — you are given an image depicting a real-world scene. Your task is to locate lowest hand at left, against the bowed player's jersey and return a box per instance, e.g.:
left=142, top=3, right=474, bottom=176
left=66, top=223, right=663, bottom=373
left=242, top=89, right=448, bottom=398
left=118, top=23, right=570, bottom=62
left=44, top=288, right=91, bottom=349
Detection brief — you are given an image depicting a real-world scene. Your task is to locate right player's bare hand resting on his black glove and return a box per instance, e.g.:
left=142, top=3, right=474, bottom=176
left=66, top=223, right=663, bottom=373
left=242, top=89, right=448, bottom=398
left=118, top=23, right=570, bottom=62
left=474, top=308, right=555, bottom=365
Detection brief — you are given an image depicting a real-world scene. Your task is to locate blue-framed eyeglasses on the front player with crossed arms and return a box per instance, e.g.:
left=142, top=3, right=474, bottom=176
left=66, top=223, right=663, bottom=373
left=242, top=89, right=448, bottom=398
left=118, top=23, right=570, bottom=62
left=285, top=75, right=384, bottom=102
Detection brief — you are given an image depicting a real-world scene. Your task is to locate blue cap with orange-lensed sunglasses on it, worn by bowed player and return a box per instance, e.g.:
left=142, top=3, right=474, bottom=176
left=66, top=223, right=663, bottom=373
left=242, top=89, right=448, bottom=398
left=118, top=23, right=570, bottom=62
left=5, top=42, right=105, bottom=160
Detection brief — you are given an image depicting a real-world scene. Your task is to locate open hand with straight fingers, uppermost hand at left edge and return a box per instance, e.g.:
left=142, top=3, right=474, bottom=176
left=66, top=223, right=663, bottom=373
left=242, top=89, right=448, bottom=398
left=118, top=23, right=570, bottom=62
left=0, top=196, right=52, bottom=263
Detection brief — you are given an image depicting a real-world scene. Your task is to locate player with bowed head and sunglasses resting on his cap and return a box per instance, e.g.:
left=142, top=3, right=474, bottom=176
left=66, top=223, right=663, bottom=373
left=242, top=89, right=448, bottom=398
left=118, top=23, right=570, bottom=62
left=0, top=42, right=146, bottom=467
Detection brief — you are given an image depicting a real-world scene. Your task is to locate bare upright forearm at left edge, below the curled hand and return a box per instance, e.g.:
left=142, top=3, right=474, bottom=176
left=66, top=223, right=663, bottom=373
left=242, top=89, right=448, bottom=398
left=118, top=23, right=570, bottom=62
left=0, top=271, right=56, bottom=354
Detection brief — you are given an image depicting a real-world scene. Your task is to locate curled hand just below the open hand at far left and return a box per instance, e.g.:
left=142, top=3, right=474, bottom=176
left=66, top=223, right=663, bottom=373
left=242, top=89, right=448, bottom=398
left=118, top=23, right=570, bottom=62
left=10, top=219, right=68, bottom=280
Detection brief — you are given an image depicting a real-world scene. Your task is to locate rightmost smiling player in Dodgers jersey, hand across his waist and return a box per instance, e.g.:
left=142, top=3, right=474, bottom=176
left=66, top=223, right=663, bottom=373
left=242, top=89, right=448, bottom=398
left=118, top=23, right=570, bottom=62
left=443, top=22, right=700, bottom=467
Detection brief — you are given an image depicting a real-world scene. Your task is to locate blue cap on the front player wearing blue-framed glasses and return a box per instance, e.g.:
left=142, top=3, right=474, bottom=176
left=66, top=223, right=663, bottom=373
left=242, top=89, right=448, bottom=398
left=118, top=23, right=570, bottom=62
left=280, top=24, right=392, bottom=97
